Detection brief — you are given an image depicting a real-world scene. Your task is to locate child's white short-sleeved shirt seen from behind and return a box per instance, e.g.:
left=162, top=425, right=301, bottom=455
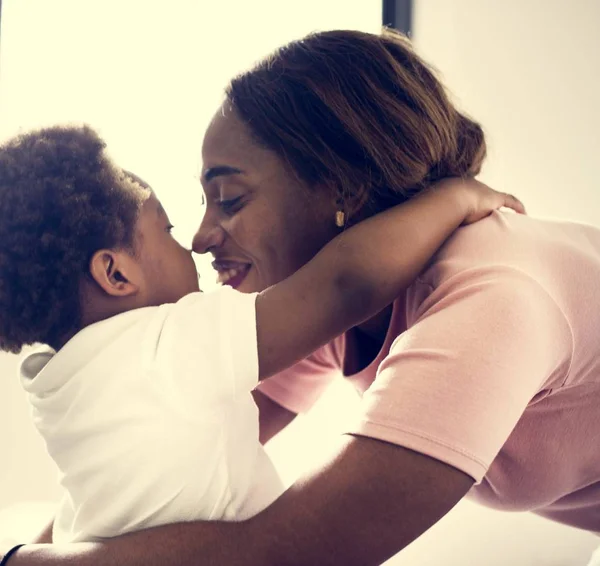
left=21, top=288, right=283, bottom=543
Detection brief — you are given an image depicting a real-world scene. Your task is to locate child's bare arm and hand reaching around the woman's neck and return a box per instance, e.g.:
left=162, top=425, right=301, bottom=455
left=256, top=179, right=524, bottom=379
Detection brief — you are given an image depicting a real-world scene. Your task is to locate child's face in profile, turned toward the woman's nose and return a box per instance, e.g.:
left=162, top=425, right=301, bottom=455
left=136, top=194, right=199, bottom=306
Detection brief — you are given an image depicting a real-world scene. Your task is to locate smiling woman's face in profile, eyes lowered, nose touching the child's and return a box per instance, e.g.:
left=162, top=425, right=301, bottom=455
left=193, top=103, right=338, bottom=293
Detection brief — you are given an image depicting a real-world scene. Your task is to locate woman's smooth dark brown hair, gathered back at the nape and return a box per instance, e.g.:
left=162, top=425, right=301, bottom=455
left=226, top=30, right=486, bottom=220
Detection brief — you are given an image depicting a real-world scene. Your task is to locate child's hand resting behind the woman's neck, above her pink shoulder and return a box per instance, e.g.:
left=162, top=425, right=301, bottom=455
left=435, top=178, right=526, bottom=224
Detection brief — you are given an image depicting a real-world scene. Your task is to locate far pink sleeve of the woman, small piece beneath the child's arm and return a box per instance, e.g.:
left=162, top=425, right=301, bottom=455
left=257, top=336, right=344, bottom=413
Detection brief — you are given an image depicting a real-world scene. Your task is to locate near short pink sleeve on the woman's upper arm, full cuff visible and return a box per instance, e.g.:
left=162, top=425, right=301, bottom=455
left=348, top=268, right=573, bottom=482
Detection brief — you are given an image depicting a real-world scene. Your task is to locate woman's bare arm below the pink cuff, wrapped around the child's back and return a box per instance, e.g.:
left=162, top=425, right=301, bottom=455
left=4, top=437, right=473, bottom=566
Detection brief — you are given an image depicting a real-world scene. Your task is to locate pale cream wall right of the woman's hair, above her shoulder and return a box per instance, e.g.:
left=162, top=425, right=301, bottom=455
left=414, top=0, right=600, bottom=225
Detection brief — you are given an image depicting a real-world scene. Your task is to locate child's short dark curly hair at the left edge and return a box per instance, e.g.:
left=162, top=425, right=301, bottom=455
left=0, top=126, right=148, bottom=353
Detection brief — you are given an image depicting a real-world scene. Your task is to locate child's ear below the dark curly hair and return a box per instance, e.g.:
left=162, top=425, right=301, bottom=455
left=89, top=250, right=141, bottom=297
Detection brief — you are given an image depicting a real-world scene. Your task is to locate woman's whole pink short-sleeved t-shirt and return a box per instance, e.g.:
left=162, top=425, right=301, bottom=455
left=261, top=213, right=600, bottom=533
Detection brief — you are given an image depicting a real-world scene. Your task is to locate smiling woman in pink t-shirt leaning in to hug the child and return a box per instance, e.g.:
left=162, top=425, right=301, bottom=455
left=5, top=31, right=600, bottom=566
